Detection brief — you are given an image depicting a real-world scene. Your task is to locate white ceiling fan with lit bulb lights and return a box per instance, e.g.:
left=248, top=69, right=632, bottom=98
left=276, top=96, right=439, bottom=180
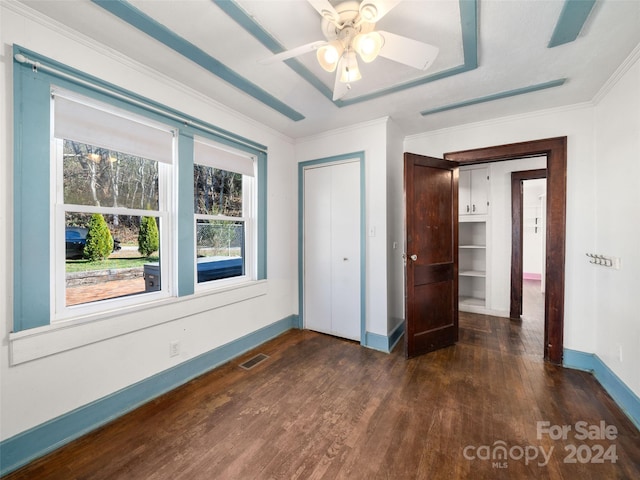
left=261, top=0, right=439, bottom=101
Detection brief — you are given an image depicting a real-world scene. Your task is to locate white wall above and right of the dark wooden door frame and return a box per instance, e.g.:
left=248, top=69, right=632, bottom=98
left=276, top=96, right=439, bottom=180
left=405, top=104, right=596, bottom=352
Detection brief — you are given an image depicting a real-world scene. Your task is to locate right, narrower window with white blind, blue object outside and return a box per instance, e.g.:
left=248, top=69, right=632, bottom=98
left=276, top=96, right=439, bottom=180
left=193, top=138, right=256, bottom=285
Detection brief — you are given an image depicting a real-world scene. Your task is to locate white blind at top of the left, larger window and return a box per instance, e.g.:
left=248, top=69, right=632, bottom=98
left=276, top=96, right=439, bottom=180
left=52, top=91, right=173, bottom=163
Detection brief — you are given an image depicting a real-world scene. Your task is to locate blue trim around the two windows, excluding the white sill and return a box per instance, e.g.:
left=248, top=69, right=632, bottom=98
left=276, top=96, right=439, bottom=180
left=13, top=45, right=267, bottom=332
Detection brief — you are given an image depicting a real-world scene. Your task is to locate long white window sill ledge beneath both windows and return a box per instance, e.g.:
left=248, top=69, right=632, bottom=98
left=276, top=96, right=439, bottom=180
left=9, top=280, right=267, bottom=366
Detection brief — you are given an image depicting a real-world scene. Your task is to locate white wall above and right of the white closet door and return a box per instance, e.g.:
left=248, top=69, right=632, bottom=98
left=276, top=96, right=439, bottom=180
left=295, top=118, right=388, bottom=336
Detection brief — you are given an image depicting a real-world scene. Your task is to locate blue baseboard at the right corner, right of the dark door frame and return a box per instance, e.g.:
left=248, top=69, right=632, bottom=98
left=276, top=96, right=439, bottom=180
left=563, top=348, right=640, bottom=430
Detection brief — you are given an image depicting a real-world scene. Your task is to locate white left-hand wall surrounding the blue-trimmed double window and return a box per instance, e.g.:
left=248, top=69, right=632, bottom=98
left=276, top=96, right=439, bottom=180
left=0, top=2, right=298, bottom=439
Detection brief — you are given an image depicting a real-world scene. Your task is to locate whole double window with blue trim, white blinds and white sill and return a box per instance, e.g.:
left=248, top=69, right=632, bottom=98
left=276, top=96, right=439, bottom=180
left=11, top=45, right=267, bottom=336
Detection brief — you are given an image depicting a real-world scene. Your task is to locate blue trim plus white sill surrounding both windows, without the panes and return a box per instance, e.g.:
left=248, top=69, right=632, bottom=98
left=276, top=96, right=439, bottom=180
left=9, top=45, right=267, bottom=342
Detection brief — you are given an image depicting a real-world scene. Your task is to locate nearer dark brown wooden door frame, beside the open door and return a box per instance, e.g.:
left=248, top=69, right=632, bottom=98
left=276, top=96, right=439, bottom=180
left=444, top=137, right=567, bottom=364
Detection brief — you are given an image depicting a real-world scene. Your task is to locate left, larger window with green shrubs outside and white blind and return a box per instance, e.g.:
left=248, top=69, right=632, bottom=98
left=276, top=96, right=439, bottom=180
left=52, top=90, right=174, bottom=320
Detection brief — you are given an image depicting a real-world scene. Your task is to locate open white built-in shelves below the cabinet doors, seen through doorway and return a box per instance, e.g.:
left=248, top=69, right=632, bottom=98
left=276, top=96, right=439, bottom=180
left=458, top=220, right=487, bottom=313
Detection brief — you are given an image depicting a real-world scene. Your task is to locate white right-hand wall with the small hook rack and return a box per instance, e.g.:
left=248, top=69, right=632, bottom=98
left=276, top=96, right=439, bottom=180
left=592, top=47, right=640, bottom=395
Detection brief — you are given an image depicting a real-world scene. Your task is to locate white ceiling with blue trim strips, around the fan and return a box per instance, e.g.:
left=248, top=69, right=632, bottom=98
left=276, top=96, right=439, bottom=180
left=15, top=0, right=640, bottom=138
